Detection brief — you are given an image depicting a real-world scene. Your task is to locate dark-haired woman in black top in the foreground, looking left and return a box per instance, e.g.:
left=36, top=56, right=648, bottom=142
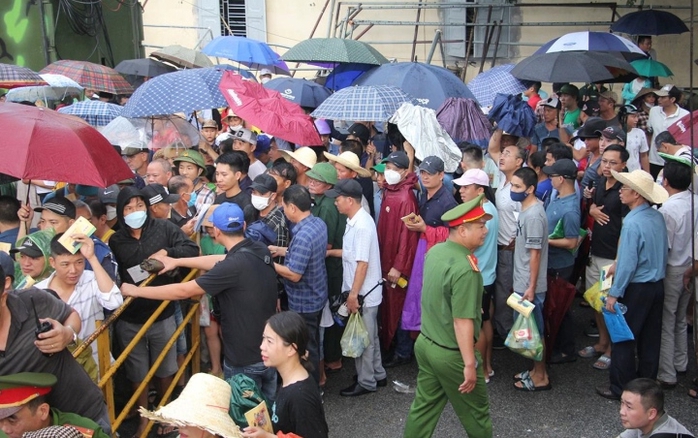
left=243, top=311, right=328, bottom=438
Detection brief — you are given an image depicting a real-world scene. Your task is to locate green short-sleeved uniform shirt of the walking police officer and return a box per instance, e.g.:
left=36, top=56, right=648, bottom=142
left=422, top=240, right=484, bottom=349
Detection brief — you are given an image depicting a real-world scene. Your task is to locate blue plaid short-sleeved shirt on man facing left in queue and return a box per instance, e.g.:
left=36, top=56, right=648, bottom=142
left=284, top=214, right=327, bottom=313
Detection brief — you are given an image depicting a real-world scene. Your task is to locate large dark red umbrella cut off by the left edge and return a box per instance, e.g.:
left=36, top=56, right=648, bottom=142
left=0, top=102, right=133, bottom=187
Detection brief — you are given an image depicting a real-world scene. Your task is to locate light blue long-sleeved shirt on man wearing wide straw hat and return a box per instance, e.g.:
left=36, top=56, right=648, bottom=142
left=608, top=204, right=669, bottom=297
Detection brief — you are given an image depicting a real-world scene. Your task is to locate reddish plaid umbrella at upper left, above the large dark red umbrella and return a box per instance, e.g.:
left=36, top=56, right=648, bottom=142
left=41, top=61, right=133, bottom=94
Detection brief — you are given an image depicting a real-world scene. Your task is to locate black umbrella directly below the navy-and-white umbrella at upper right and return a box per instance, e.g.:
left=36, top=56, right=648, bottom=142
left=511, top=52, right=637, bottom=83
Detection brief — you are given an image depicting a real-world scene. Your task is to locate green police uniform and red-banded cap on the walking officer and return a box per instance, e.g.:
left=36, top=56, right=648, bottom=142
left=404, top=196, right=492, bottom=438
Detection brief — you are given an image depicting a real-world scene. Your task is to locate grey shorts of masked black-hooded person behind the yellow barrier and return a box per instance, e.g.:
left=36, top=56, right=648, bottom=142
left=116, top=315, right=177, bottom=383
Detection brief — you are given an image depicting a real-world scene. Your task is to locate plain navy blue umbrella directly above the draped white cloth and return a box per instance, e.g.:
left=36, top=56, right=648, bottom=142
left=354, top=62, right=475, bottom=110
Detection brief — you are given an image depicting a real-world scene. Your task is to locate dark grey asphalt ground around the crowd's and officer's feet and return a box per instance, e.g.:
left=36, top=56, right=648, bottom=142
left=324, top=300, right=698, bottom=438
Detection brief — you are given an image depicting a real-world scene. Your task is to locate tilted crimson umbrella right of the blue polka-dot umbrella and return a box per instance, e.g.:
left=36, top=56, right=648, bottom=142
left=219, top=71, right=322, bottom=146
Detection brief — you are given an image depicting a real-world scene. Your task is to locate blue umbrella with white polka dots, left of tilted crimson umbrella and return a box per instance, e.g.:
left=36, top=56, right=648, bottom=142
left=121, top=67, right=228, bottom=117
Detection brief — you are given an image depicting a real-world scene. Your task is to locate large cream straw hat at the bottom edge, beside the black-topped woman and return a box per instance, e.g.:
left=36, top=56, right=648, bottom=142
left=139, top=373, right=242, bottom=438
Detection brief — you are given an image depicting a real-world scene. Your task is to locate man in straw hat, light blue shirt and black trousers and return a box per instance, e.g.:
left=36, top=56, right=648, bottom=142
left=596, top=169, right=669, bottom=400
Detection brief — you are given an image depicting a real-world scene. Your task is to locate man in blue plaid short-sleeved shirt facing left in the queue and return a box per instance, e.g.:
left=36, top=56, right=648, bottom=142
left=270, top=185, right=327, bottom=382
